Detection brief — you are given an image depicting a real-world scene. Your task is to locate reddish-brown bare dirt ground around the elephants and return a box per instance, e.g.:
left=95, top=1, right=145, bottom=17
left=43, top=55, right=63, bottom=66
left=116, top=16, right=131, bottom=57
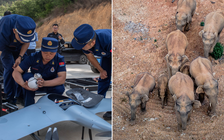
left=113, top=0, right=224, bottom=140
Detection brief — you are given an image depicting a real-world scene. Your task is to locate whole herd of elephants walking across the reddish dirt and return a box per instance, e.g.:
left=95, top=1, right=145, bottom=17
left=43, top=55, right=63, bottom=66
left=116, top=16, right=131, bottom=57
left=127, top=0, right=224, bottom=130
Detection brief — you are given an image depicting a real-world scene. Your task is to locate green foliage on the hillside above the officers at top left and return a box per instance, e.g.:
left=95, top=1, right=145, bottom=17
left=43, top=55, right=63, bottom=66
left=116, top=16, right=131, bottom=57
left=0, top=0, right=75, bottom=21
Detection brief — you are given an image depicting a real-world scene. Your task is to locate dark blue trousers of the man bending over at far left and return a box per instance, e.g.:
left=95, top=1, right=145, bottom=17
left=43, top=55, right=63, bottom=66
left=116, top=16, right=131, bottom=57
left=1, top=48, right=20, bottom=103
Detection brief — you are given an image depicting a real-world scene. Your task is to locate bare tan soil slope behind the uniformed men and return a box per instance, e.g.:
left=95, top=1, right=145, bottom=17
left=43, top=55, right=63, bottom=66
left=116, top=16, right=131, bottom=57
left=37, top=0, right=112, bottom=48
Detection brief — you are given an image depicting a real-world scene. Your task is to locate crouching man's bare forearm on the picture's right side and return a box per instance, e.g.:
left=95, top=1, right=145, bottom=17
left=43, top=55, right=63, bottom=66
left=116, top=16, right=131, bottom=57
left=43, top=71, right=66, bottom=87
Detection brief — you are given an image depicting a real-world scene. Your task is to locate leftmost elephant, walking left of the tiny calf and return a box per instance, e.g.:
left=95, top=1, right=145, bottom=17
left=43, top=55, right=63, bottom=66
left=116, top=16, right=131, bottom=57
left=127, top=72, right=155, bottom=125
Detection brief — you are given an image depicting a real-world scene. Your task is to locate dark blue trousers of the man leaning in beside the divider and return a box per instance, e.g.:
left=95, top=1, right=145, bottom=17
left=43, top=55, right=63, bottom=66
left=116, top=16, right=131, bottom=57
left=98, top=57, right=112, bottom=98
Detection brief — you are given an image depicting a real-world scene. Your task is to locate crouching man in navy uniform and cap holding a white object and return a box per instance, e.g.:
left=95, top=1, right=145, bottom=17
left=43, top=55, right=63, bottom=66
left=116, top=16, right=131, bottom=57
left=13, top=37, right=66, bottom=107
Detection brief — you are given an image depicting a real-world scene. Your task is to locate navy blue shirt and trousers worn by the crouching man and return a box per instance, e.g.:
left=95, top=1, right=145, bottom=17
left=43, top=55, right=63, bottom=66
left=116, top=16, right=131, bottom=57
left=19, top=52, right=66, bottom=106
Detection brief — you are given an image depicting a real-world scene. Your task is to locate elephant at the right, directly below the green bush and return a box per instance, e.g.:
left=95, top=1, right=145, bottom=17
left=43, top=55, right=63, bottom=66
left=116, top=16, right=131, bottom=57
left=190, top=57, right=218, bottom=117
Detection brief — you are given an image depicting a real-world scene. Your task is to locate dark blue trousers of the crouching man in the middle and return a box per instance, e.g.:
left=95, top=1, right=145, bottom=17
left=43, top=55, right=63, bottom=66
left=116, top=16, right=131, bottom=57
left=23, top=73, right=65, bottom=107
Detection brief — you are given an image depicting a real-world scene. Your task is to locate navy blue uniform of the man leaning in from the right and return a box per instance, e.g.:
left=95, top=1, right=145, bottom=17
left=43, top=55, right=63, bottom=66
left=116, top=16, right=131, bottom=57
left=83, top=29, right=112, bottom=97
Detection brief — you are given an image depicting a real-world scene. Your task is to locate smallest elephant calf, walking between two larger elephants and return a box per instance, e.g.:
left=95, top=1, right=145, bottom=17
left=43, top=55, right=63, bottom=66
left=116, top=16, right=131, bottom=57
left=158, top=74, right=168, bottom=108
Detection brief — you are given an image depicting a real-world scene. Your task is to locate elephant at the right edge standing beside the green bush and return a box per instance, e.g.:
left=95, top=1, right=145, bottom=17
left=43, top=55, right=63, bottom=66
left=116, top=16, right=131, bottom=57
left=199, top=11, right=224, bottom=58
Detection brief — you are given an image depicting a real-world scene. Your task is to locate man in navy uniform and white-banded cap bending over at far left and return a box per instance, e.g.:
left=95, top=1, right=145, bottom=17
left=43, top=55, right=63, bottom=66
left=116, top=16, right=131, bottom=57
left=0, top=14, right=36, bottom=104
